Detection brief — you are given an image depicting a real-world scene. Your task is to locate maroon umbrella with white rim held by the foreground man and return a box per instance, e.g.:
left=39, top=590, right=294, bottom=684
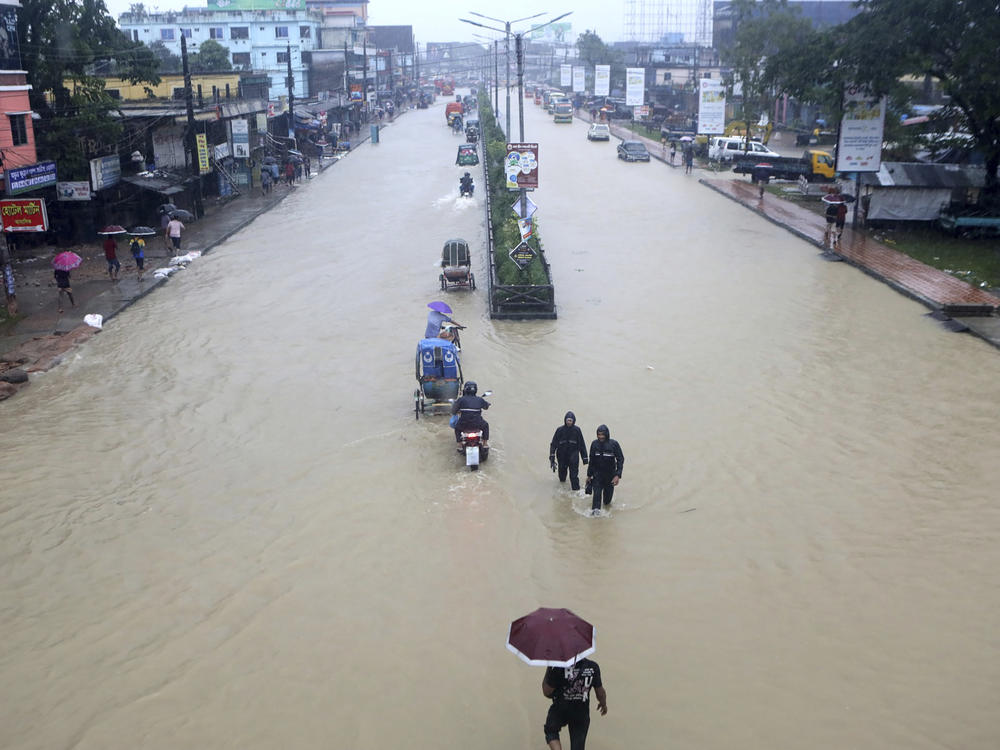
left=507, top=607, right=596, bottom=667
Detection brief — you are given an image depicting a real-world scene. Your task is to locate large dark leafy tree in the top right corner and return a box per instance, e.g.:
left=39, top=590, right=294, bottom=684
left=844, top=0, right=1000, bottom=204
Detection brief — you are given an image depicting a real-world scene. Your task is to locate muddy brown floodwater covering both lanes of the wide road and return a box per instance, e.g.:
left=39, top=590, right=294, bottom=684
left=0, top=101, right=1000, bottom=750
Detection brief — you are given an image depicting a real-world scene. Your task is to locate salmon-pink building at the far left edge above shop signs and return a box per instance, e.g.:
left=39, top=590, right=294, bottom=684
left=0, top=0, right=38, bottom=185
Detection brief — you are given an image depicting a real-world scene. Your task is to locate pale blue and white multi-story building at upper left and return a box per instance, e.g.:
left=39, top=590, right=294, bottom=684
left=118, top=5, right=322, bottom=97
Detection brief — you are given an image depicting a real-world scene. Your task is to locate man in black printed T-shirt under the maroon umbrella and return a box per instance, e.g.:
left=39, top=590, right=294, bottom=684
left=542, top=659, right=608, bottom=750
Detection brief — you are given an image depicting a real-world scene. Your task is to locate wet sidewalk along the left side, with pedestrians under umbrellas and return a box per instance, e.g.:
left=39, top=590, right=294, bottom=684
left=0, top=117, right=382, bottom=400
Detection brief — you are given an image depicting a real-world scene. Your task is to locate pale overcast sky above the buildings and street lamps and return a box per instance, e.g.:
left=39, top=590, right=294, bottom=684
left=106, top=0, right=625, bottom=44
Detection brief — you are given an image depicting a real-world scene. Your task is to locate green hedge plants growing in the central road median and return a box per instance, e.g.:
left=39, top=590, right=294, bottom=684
left=479, top=97, right=550, bottom=284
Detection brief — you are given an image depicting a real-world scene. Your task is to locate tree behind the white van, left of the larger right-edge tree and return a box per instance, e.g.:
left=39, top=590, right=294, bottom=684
left=720, top=0, right=811, bottom=150
